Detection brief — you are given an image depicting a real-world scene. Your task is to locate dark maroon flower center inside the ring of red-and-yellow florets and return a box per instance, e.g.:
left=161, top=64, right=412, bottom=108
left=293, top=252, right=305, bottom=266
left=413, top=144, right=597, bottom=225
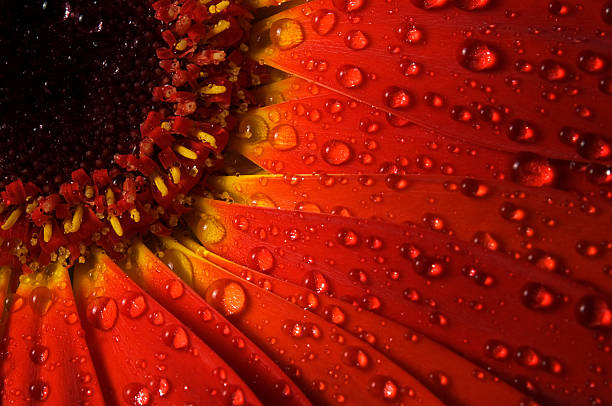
left=0, top=0, right=160, bottom=192
